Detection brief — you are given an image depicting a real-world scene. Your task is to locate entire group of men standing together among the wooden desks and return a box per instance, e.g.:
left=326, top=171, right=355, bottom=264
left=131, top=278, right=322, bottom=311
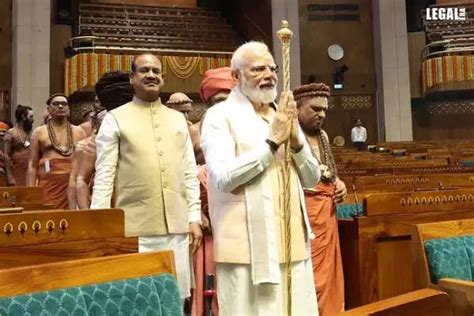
left=3, top=42, right=352, bottom=316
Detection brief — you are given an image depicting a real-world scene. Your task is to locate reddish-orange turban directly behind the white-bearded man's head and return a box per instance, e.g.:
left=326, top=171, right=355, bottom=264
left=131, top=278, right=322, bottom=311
left=200, top=67, right=234, bottom=103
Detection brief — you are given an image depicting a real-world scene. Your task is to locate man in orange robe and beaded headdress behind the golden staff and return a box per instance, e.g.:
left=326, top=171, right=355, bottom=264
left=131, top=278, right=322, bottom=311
left=293, top=83, right=347, bottom=316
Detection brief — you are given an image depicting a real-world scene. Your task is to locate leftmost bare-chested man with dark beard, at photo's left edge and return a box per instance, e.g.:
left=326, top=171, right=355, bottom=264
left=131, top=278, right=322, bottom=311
left=4, top=104, right=34, bottom=187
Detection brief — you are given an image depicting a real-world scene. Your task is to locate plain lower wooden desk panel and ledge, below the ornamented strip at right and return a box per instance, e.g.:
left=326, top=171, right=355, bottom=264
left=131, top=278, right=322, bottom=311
left=339, top=210, right=474, bottom=308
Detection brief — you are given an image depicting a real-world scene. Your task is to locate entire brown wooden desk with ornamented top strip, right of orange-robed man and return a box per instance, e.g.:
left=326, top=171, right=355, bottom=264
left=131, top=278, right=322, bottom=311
left=339, top=189, right=474, bottom=308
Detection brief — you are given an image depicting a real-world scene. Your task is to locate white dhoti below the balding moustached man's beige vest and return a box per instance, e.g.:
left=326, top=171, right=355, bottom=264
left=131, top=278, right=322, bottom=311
left=138, top=234, right=192, bottom=300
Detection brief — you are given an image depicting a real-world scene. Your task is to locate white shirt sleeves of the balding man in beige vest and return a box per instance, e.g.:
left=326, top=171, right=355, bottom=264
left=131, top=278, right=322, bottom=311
left=91, top=113, right=201, bottom=223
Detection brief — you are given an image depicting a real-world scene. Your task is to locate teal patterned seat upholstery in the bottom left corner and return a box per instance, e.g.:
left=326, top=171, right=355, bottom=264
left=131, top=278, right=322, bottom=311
left=0, top=273, right=182, bottom=316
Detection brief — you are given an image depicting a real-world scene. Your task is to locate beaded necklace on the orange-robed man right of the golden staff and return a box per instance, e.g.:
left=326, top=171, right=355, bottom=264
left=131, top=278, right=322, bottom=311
left=306, top=129, right=337, bottom=183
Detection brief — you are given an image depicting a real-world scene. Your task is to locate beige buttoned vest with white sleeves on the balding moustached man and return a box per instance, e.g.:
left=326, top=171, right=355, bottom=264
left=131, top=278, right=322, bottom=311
left=91, top=97, right=200, bottom=236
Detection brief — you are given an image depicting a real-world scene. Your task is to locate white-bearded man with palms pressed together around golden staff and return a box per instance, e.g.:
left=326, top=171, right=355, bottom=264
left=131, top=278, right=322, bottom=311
left=201, top=42, right=320, bottom=315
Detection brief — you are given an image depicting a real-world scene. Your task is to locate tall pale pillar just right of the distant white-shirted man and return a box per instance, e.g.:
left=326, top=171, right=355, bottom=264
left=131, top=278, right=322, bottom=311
left=372, top=0, right=413, bottom=141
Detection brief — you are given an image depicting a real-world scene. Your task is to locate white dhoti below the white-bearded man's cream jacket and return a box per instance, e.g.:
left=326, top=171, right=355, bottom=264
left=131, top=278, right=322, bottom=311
left=216, top=259, right=319, bottom=316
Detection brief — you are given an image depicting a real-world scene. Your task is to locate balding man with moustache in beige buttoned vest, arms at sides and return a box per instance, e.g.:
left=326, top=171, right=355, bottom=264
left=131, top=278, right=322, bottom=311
left=91, top=54, right=202, bottom=300
